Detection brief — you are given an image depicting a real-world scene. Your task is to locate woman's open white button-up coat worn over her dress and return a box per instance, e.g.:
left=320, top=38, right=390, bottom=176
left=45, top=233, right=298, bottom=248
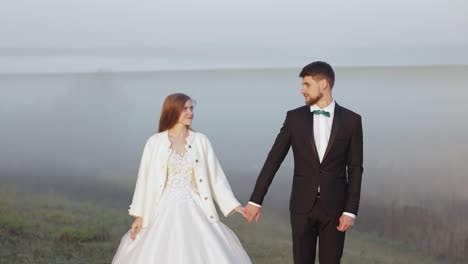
left=128, top=130, right=240, bottom=228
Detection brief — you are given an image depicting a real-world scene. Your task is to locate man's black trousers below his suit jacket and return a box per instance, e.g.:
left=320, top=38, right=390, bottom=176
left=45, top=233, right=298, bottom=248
left=291, top=198, right=345, bottom=264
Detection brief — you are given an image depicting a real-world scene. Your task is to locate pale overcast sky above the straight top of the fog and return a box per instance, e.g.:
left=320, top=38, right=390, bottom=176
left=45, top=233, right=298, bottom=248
left=0, top=0, right=468, bottom=73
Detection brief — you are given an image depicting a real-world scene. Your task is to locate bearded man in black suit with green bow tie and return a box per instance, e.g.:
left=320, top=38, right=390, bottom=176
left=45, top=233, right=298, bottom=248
left=245, top=61, right=363, bottom=264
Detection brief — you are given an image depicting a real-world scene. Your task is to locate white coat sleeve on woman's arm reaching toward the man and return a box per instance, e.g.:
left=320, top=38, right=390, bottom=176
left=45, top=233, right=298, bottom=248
left=205, top=137, right=241, bottom=217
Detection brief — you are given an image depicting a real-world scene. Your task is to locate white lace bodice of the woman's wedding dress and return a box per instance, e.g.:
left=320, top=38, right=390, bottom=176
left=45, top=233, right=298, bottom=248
left=166, top=151, right=195, bottom=192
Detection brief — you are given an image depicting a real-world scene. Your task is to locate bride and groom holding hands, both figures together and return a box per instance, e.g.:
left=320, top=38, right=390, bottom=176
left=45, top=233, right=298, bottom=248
left=112, top=61, right=363, bottom=264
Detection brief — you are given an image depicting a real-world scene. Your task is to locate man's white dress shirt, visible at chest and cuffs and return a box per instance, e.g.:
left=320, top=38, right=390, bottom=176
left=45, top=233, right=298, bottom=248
left=249, top=100, right=356, bottom=219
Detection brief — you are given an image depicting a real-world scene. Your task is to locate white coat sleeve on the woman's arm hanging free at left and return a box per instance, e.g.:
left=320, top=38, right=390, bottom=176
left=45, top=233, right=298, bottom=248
left=128, top=138, right=151, bottom=217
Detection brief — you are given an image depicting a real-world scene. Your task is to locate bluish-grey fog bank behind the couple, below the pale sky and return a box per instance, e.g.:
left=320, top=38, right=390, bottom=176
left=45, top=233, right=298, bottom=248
left=0, top=66, right=468, bottom=206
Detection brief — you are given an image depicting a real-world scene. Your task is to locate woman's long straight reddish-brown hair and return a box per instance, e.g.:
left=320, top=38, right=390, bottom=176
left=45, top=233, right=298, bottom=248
left=158, top=93, right=193, bottom=132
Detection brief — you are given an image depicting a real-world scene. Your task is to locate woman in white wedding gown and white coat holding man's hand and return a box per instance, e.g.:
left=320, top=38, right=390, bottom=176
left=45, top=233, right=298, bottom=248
left=112, top=93, right=251, bottom=264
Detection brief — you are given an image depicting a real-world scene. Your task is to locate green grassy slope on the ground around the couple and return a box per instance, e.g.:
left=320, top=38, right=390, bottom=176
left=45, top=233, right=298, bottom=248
left=0, top=187, right=450, bottom=264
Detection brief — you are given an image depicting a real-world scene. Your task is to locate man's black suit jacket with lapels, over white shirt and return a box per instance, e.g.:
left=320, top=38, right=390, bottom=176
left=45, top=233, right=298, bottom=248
left=250, top=104, right=363, bottom=216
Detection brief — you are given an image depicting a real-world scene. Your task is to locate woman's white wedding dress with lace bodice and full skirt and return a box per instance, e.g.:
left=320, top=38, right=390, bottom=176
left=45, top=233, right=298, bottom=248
left=112, top=151, right=251, bottom=264
